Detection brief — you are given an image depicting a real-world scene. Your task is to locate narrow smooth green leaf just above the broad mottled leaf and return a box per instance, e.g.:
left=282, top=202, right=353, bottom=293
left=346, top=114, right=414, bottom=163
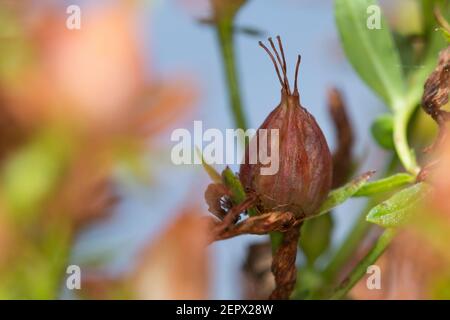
left=353, top=173, right=415, bottom=197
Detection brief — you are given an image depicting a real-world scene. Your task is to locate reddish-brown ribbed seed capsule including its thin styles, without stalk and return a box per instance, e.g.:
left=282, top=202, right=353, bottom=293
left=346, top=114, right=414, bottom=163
left=239, top=37, right=332, bottom=219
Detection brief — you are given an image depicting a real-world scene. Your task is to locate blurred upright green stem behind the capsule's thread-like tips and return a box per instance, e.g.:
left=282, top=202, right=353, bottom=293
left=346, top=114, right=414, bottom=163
left=216, top=18, right=247, bottom=130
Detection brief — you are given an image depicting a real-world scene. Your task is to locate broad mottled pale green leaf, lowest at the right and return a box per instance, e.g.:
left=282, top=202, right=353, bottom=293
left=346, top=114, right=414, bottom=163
left=366, top=182, right=429, bottom=228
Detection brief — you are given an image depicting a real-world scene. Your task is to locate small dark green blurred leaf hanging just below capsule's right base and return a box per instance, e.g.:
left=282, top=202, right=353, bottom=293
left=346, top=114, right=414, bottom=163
left=299, top=214, right=333, bottom=265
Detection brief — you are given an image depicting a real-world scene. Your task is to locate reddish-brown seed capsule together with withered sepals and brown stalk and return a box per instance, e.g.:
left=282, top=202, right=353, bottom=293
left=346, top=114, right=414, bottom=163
left=205, top=36, right=333, bottom=299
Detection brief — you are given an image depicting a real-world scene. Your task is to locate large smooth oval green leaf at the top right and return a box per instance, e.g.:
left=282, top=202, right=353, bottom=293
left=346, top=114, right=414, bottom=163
left=335, top=0, right=405, bottom=107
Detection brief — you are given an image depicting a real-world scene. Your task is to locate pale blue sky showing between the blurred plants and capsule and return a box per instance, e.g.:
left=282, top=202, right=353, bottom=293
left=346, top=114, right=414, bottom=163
left=65, top=0, right=392, bottom=299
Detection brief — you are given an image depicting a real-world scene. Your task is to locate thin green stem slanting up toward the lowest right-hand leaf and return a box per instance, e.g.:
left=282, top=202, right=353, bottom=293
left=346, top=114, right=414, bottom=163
left=330, top=229, right=396, bottom=300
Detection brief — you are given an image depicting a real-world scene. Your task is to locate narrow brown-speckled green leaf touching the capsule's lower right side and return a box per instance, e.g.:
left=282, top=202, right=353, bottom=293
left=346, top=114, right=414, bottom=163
left=311, top=171, right=375, bottom=218
